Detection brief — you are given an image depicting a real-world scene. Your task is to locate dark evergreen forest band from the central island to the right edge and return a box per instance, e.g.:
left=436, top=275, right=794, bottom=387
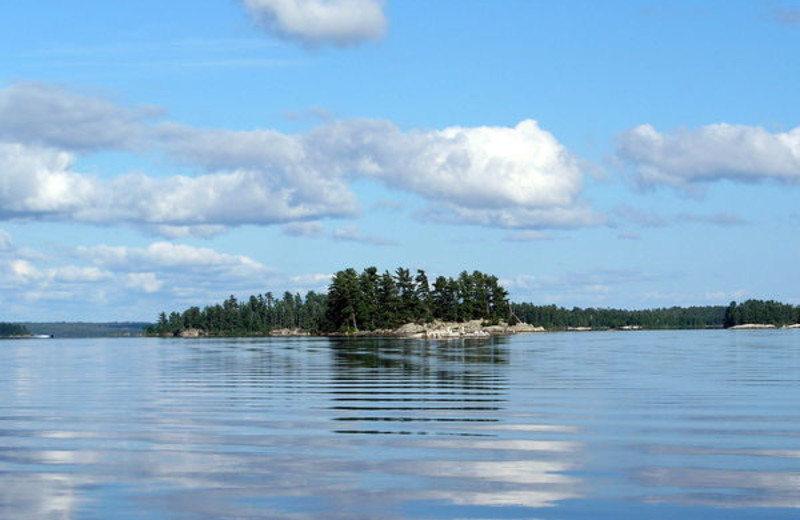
left=145, top=267, right=800, bottom=336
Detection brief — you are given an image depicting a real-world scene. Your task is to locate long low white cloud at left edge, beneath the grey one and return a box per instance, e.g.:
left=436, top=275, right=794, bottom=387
left=0, top=143, right=356, bottom=232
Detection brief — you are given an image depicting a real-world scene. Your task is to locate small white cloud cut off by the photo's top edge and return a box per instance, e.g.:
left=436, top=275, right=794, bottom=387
left=242, top=0, right=387, bottom=47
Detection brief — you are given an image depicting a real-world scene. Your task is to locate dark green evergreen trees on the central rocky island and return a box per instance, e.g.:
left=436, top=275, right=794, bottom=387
left=145, top=267, right=509, bottom=336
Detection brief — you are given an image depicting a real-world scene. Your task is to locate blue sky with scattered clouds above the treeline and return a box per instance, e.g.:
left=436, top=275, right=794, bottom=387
left=0, top=0, right=800, bottom=321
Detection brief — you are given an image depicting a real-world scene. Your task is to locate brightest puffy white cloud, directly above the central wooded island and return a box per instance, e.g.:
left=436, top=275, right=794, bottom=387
left=307, top=120, right=582, bottom=209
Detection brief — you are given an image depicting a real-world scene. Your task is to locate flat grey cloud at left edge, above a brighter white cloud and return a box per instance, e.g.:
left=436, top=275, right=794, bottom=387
left=0, top=83, right=160, bottom=151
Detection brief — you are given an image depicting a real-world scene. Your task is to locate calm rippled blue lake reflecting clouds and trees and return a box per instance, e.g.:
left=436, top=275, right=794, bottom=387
left=0, top=330, right=800, bottom=520
